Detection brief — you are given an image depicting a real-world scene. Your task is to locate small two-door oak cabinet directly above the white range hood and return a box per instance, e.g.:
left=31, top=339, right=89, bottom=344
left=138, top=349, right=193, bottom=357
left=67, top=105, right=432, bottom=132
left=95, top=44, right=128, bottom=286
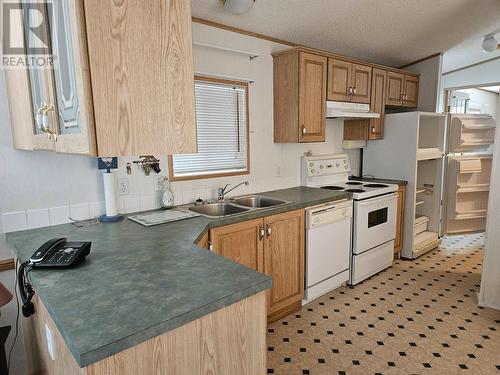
left=327, top=58, right=372, bottom=103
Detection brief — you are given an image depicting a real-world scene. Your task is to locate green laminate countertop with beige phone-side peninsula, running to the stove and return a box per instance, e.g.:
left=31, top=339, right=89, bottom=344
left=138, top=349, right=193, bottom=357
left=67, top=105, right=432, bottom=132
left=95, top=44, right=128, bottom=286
left=7, top=187, right=350, bottom=367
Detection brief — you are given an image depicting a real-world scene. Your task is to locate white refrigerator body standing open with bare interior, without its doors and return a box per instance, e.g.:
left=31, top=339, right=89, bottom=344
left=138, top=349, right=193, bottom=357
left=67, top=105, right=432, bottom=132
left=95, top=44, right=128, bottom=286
left=363, top=112, right=447, bottom=259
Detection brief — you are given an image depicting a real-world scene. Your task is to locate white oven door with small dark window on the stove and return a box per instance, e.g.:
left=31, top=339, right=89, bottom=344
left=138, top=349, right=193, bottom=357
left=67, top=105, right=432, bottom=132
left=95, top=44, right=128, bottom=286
left=352, top=193, right=397, bottom=254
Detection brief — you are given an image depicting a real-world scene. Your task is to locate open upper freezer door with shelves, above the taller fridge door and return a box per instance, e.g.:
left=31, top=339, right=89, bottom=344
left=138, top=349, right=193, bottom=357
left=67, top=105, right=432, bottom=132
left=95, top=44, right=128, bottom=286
left=447, top=114, right=496, bottom=154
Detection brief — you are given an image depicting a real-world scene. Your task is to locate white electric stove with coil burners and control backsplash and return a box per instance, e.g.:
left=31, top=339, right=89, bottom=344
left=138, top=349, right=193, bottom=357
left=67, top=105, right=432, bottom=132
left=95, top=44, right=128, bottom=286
left=301, top=154, right=398, bottom=285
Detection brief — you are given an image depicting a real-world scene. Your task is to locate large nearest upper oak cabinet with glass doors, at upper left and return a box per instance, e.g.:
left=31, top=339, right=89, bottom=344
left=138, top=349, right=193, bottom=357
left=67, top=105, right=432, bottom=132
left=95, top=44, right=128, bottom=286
left=6, top=0, right=196, bottom=156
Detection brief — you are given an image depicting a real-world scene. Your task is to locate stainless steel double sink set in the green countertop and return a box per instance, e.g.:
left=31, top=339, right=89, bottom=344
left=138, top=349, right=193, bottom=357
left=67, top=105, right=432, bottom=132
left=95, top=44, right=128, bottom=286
left=189, top=195, right=290, bottom=217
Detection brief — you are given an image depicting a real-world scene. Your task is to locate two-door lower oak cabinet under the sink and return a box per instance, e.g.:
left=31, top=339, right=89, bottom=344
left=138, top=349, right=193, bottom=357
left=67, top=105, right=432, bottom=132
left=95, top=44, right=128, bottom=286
left=209, top=210, right=305, bottom=321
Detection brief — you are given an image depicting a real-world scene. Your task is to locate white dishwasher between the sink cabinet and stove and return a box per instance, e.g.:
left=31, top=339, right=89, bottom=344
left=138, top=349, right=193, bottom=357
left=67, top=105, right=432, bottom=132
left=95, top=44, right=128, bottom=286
left=302, top=200, right=352, bottom=304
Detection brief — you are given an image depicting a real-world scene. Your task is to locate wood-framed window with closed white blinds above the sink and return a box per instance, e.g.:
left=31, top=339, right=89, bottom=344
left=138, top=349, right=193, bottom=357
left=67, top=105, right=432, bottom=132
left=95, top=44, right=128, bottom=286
left=169, top=77, right=249, bottom=181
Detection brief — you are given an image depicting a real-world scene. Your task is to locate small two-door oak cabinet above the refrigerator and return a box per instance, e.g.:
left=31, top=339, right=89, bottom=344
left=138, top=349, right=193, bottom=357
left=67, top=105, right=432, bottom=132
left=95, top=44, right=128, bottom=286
left=385, top=71, right=419, bottom=108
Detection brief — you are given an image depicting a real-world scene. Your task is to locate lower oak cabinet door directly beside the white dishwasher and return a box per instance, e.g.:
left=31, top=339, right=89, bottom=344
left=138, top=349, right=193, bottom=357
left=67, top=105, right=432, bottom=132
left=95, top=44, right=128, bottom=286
left=264, top=210, right=305, bottom=316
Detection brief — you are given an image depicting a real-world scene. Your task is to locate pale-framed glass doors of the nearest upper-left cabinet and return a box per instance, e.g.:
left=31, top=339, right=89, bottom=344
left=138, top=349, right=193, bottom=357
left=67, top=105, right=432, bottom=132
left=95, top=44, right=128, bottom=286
left=5, top=1, right=96, bottom=155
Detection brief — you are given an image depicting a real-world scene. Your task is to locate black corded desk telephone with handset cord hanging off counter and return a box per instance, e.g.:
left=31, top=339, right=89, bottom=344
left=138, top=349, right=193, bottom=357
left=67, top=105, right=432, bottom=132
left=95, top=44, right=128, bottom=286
left=17, top=238, right=91, bottom=317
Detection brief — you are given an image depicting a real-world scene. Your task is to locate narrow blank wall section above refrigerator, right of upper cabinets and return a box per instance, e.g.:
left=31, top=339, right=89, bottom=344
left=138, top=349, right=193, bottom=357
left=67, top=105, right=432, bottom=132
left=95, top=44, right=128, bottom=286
left=405, top=55, right=442, bottom=112
